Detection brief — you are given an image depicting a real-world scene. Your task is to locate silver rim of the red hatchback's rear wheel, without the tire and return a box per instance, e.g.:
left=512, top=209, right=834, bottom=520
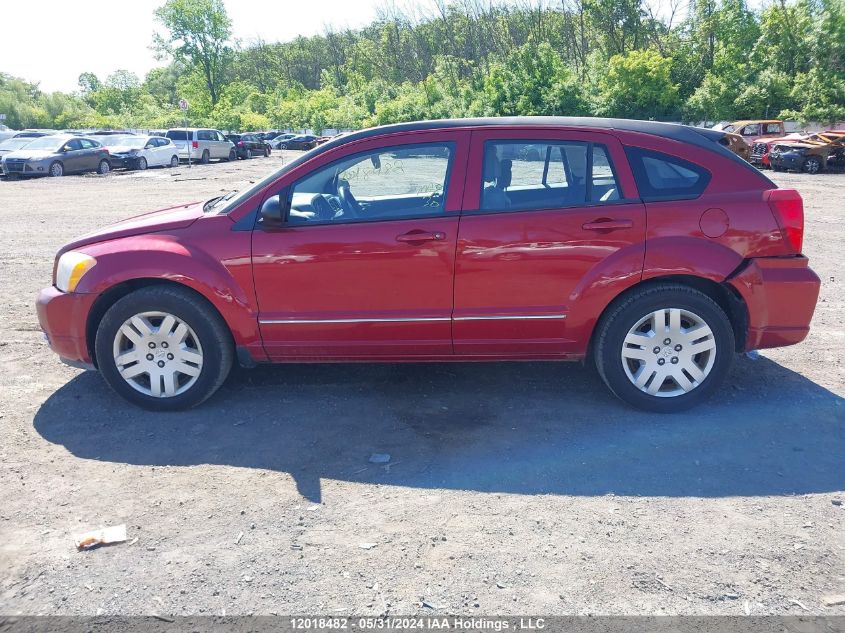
left=621, top=308, right=716, bottom=398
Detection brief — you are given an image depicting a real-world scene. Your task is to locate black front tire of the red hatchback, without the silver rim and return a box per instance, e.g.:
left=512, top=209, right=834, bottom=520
left=94, top=286, right=234, bottom=411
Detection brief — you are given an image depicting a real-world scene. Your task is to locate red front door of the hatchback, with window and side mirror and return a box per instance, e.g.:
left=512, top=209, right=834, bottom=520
left=253, top=132, right=469, bottom=360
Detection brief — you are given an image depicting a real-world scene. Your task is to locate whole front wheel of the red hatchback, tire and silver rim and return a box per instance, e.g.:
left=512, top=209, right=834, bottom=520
left=95, top=286, right=233, bottom=411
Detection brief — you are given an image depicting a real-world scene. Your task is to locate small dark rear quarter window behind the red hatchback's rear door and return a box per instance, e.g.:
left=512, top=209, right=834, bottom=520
left=625, top=147, right=710, bottom=202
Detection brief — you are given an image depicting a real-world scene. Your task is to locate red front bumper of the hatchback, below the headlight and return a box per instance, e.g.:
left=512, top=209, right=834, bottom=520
left=35, top=286, right=97, bottom=367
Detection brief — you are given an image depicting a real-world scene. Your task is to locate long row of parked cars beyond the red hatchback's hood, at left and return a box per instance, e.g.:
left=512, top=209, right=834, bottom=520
left=0, top=128, right=327, bottom=178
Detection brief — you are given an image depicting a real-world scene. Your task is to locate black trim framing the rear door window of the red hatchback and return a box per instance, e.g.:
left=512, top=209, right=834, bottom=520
left=474, top=138, right=638, bottom=215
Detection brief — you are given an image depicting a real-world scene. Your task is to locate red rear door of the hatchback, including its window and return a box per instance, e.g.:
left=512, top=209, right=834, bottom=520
left=453, top=128, right=646, bottom=357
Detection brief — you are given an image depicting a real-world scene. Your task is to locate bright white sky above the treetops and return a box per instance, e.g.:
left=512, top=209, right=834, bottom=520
left=0, top=0, right=385, bottom=92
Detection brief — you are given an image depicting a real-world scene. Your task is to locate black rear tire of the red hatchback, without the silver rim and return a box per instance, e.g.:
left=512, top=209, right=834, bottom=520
left=594, top=283, right=736, bottom=413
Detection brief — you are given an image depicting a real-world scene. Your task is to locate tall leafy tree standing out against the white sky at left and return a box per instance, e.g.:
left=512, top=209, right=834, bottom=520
left=153, top=0, right=232, bottom=105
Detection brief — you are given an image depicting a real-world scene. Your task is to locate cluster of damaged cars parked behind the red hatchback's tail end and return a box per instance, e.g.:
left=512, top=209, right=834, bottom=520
left=722, top=120, right=845, bottom=174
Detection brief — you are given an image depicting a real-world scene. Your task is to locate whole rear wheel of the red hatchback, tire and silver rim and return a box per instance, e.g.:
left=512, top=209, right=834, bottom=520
left=595, top=284, right=735, bottom=413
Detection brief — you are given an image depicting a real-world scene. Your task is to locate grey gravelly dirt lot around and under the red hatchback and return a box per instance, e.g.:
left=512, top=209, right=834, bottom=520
left=0, top=154, right=845, bottom=615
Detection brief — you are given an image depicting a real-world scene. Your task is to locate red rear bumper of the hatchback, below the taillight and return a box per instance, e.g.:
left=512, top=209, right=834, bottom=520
left=729, top=255, right=821, bottom=350
